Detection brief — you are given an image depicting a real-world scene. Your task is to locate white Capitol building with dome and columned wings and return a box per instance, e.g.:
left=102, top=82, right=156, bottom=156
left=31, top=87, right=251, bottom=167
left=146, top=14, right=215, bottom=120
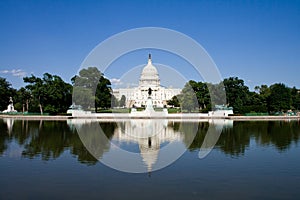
left=113, top=54, right=181, bottom=107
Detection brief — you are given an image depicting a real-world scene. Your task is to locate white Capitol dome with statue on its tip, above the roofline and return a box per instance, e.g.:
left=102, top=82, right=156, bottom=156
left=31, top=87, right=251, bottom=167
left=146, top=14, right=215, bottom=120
left=140, top=54, right=160, bottom=87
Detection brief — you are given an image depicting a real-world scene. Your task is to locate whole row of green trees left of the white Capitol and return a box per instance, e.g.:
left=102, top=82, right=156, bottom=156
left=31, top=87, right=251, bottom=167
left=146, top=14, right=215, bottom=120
left=0, top=67, right=111, bottom=114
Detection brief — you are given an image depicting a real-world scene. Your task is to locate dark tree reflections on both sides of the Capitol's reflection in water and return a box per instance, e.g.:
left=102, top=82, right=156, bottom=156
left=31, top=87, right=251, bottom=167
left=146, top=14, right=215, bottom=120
left=0, top=119, right=300, bottom=159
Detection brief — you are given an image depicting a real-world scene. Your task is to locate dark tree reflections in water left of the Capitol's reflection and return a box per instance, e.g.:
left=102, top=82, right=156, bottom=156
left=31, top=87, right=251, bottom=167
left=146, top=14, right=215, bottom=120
left=0, top=120, right=116, bottom=164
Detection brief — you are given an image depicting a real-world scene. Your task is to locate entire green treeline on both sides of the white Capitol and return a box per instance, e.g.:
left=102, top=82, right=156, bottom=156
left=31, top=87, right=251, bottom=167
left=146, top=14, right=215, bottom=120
left=0, top=67, right=300, bottom=114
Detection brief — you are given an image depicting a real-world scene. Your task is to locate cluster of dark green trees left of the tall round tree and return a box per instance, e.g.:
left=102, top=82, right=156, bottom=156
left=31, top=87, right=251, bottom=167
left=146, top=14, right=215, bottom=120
left=0, top=73, right=72, bottom=114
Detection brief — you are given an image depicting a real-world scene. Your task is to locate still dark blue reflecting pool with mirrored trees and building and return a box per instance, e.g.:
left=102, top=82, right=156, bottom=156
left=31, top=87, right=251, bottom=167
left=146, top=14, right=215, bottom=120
left=0, top=119, right=300, bottom=199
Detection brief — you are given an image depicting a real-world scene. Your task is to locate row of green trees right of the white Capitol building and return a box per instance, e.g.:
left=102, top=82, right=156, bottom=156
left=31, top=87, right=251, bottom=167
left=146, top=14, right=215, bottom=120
left=168, top=77, right=300, bottom=114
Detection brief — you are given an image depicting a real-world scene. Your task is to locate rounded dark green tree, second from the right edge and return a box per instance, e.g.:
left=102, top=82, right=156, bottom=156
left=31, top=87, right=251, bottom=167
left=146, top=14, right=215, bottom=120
left=268, top=83, right=292, bottom=112
